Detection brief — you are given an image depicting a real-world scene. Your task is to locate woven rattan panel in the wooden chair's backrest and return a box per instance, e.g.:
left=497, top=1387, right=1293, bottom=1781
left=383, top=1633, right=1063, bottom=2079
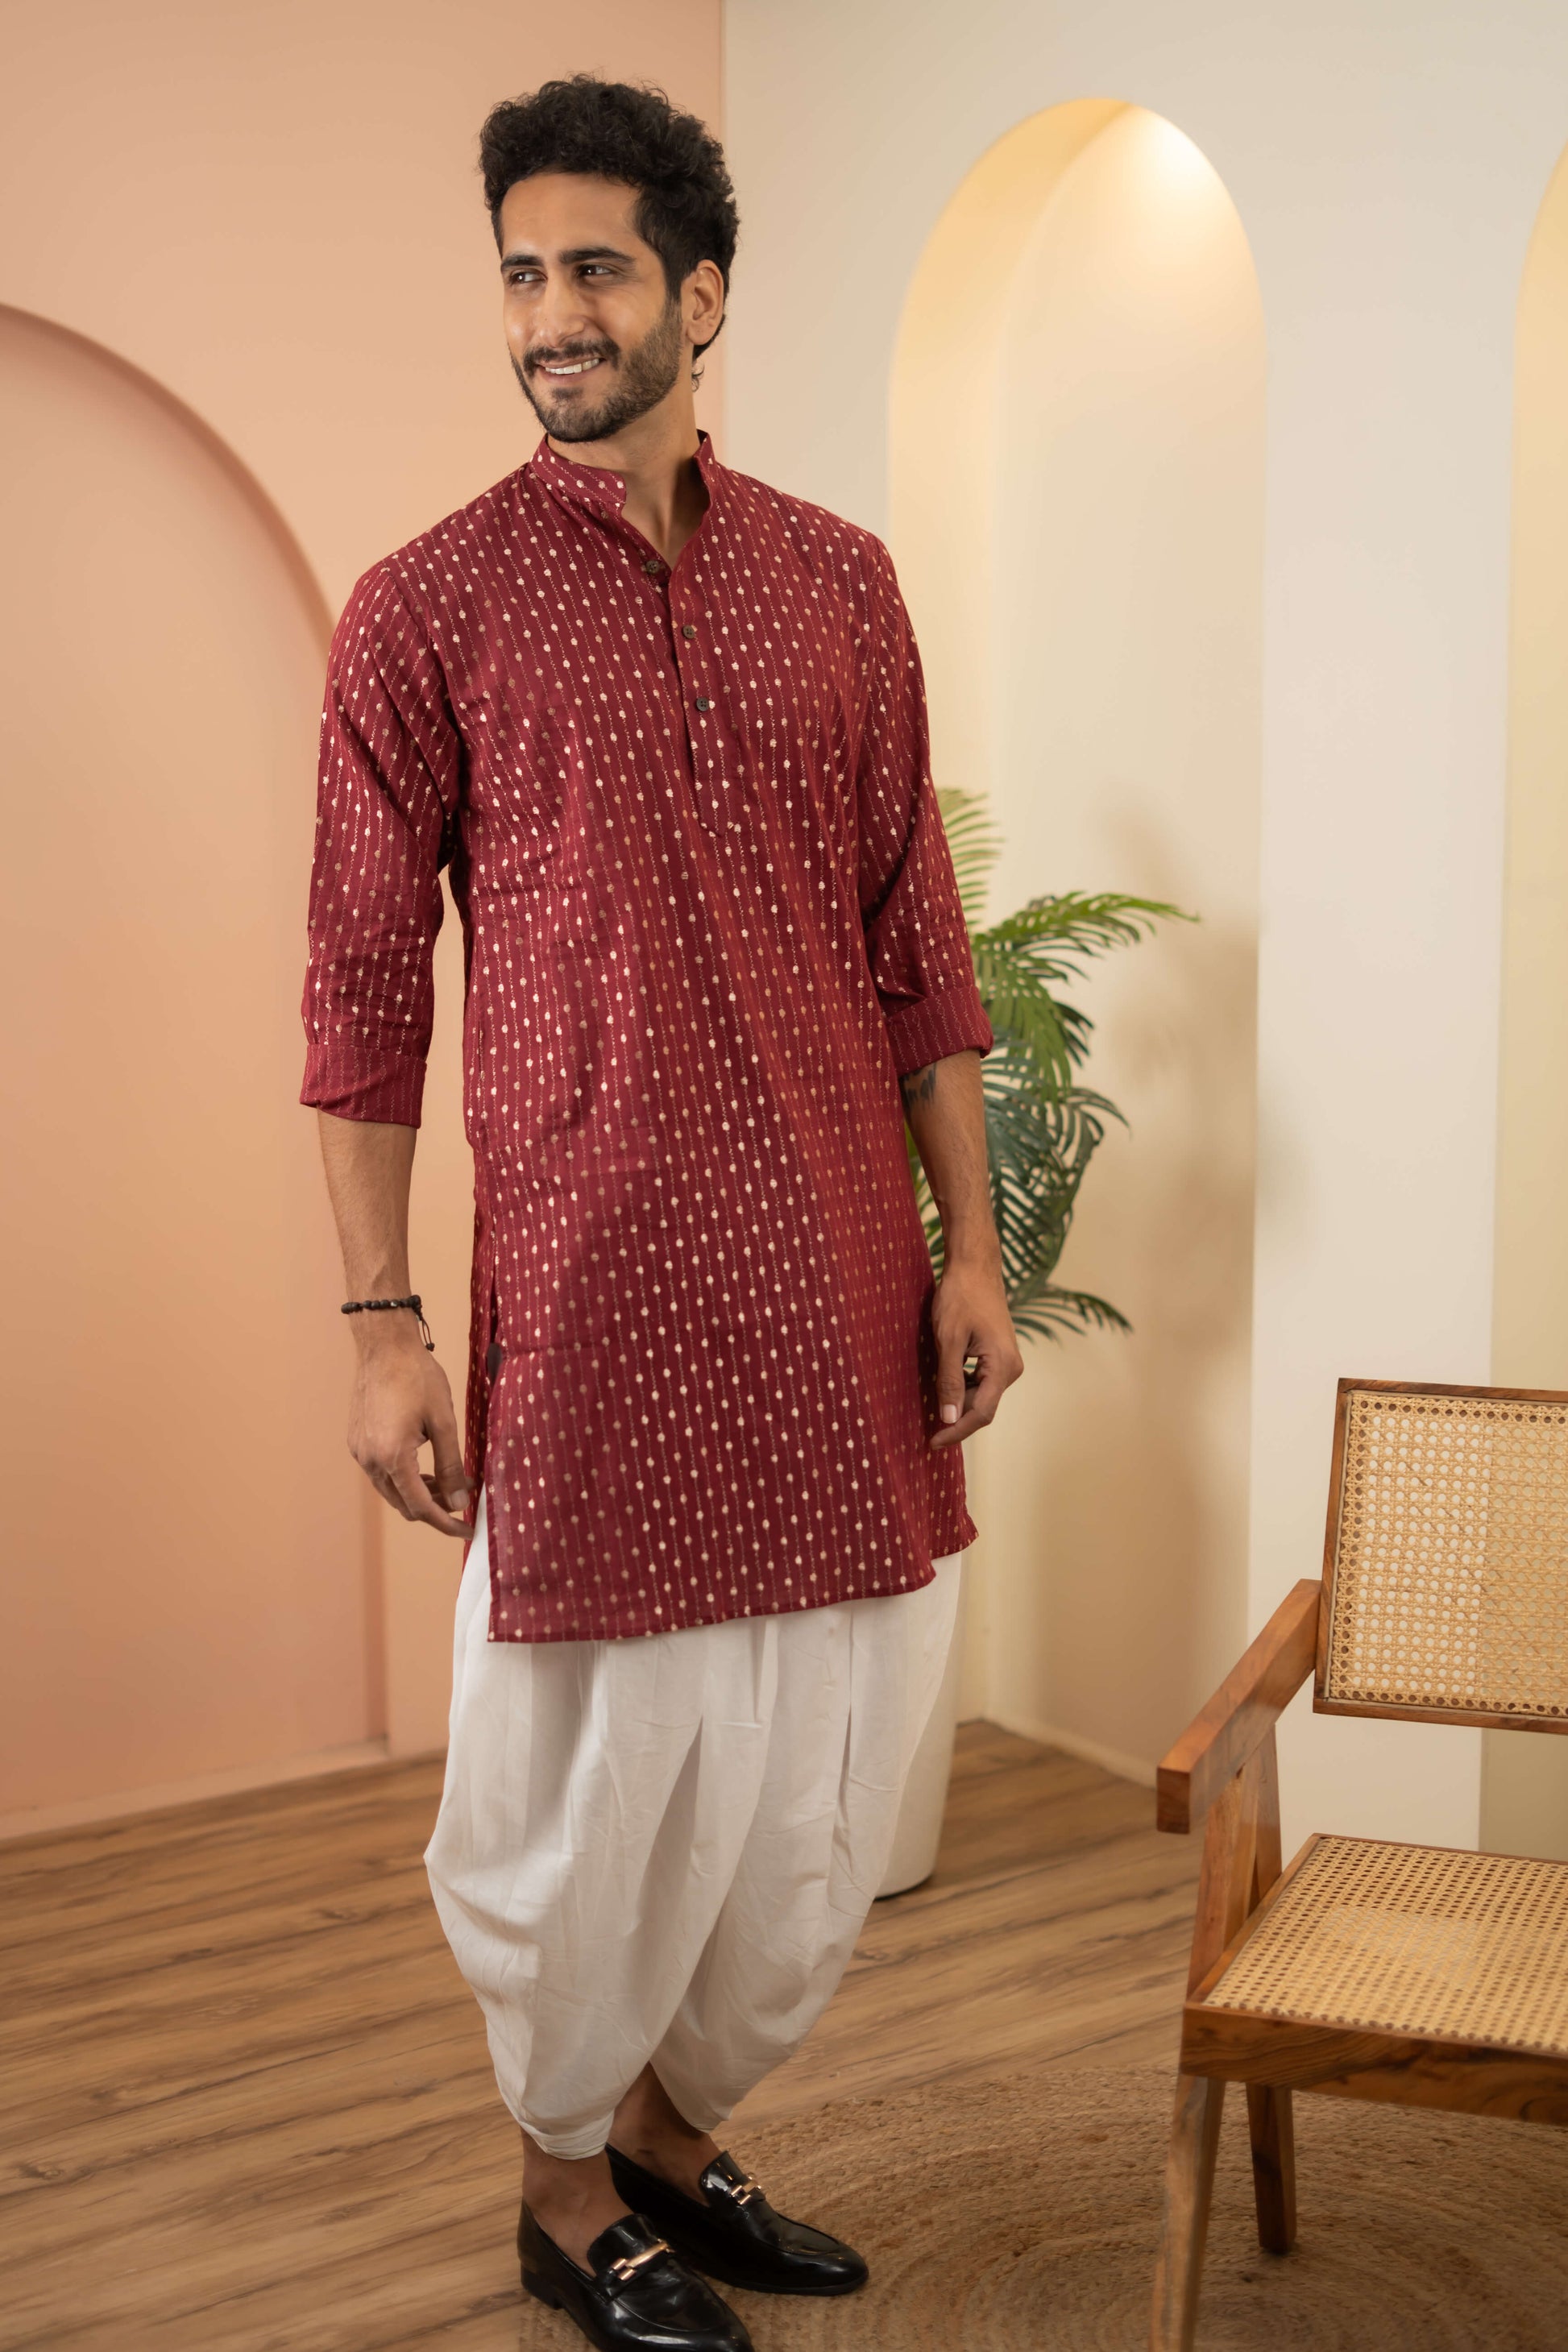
left=1321, top=1388, right=1568, bottom=1719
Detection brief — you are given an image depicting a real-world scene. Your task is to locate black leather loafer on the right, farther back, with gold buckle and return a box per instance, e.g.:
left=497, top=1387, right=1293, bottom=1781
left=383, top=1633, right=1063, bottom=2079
left=607, top=2147, right=865, bottom=2296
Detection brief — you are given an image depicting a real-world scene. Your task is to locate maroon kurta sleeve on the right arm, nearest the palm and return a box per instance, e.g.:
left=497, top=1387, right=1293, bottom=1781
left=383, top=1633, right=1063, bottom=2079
left=856, top=543, right=994, bottom=1077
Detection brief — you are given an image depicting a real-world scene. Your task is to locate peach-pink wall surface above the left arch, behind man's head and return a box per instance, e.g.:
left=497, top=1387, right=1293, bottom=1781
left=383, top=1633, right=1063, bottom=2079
left=0, top=0, right=720, bottom=609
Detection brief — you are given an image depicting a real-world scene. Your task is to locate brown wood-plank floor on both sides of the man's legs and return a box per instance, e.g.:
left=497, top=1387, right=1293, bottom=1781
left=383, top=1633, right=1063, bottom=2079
left=0, top=1724, right=1197, bottom=2352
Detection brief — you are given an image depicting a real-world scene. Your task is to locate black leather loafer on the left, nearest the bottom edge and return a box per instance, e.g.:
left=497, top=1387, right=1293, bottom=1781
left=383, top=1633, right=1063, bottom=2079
left=517, top=2204, right=753, bottom=2352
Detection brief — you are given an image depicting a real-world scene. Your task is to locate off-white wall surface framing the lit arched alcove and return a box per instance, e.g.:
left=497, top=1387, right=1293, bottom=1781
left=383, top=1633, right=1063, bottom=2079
left=727, top=0, right=1568, bottom=1842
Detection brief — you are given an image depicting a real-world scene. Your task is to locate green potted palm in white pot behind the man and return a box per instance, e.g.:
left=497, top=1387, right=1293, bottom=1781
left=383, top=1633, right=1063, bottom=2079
left=879, top=790, right=1192, bottom=1896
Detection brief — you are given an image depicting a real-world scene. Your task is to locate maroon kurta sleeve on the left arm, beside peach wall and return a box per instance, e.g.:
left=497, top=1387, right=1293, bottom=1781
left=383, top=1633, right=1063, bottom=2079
left=301, top=566, right=461, bottom=1126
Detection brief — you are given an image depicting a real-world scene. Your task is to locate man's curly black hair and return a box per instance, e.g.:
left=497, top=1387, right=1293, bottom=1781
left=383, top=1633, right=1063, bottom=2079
left=479, top=73, right=740, bottom=348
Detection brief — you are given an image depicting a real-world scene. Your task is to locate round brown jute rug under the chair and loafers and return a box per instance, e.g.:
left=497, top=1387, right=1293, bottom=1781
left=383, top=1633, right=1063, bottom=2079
left=541, top=2068, right=1568, bottom=2352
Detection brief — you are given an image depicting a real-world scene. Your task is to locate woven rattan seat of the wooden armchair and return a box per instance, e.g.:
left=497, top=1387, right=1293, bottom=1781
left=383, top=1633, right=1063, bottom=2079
left=1209, top=1837, right=1568, bottom=2053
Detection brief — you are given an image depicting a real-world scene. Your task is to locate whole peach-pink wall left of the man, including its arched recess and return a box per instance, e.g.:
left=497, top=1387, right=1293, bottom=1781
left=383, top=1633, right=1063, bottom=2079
left=0, top=0, right=722, bottom=1827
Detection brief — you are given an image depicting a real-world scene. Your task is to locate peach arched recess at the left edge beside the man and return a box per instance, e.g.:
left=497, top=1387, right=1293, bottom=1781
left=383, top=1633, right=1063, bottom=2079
left=0, top=310, right=381, bottom=1811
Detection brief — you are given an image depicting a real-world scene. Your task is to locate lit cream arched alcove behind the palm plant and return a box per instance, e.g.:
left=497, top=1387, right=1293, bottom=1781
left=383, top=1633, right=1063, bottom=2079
left=891, top=102, right=1265, bottom=1776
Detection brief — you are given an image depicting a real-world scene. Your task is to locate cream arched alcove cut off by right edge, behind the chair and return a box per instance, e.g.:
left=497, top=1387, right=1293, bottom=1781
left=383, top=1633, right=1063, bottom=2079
left=1481, top=151, right=1568, bottom=1860
